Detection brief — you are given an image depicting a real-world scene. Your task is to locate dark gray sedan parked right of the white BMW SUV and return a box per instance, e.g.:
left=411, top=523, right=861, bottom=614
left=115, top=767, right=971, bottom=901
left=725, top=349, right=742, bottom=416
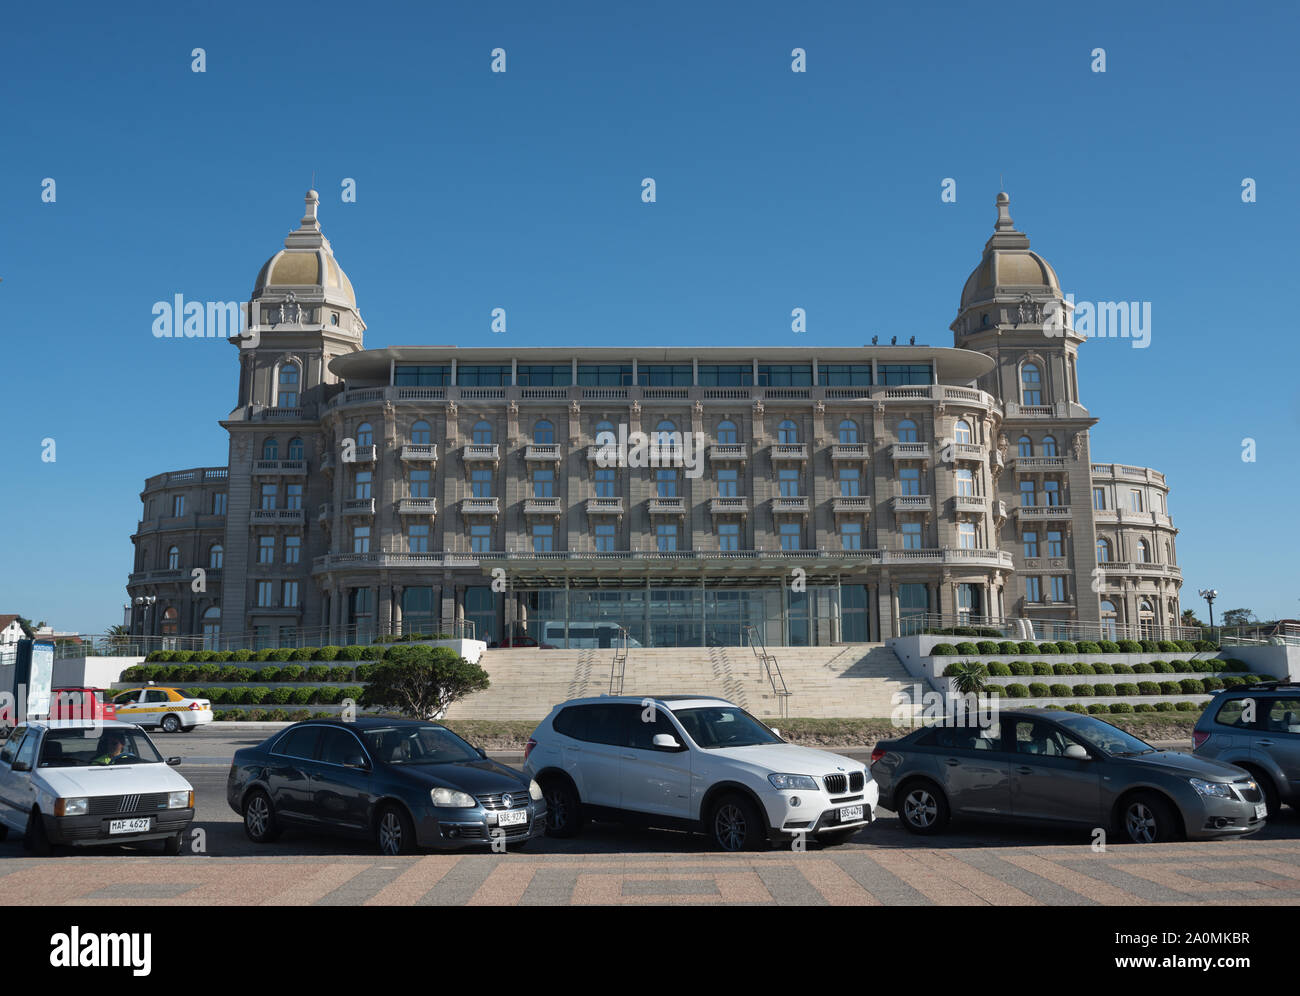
left=871, top=709, right=1265, bottom=844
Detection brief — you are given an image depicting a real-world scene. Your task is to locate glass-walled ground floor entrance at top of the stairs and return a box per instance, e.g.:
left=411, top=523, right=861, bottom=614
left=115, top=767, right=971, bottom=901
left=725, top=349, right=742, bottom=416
left=514, top=581, right=874, bottom=648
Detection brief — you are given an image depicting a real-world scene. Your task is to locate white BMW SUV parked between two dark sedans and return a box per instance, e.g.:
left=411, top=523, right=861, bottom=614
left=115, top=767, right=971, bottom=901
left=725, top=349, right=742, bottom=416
left=524, top=696, right=879, bottom=850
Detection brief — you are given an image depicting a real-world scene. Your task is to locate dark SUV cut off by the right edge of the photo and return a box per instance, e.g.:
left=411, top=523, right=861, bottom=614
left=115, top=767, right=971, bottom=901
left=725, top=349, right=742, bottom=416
left=1192, top=681, right=1300, bottom=817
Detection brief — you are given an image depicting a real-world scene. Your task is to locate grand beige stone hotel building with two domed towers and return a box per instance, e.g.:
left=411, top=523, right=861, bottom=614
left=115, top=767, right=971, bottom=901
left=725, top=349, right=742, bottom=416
left=127, top=191, right=1182, bottom=646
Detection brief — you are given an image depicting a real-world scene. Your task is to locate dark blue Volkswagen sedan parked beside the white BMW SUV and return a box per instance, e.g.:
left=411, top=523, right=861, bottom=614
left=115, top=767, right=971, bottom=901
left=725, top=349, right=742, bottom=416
left=226, top=718, right=546, bottom=854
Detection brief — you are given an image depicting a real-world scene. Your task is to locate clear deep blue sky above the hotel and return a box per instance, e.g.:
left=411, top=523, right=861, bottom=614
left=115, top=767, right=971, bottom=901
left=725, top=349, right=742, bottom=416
left=0, top=0, right=1300, bottom=632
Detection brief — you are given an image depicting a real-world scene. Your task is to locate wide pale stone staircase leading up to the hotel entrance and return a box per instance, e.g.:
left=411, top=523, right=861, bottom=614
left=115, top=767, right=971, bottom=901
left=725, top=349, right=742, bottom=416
left=447, top=644, right=915, bottom=720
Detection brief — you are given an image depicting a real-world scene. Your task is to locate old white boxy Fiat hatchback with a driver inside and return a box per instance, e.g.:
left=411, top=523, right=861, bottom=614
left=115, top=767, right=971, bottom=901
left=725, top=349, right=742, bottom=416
left=0, top=720, right=194, bottom=854
